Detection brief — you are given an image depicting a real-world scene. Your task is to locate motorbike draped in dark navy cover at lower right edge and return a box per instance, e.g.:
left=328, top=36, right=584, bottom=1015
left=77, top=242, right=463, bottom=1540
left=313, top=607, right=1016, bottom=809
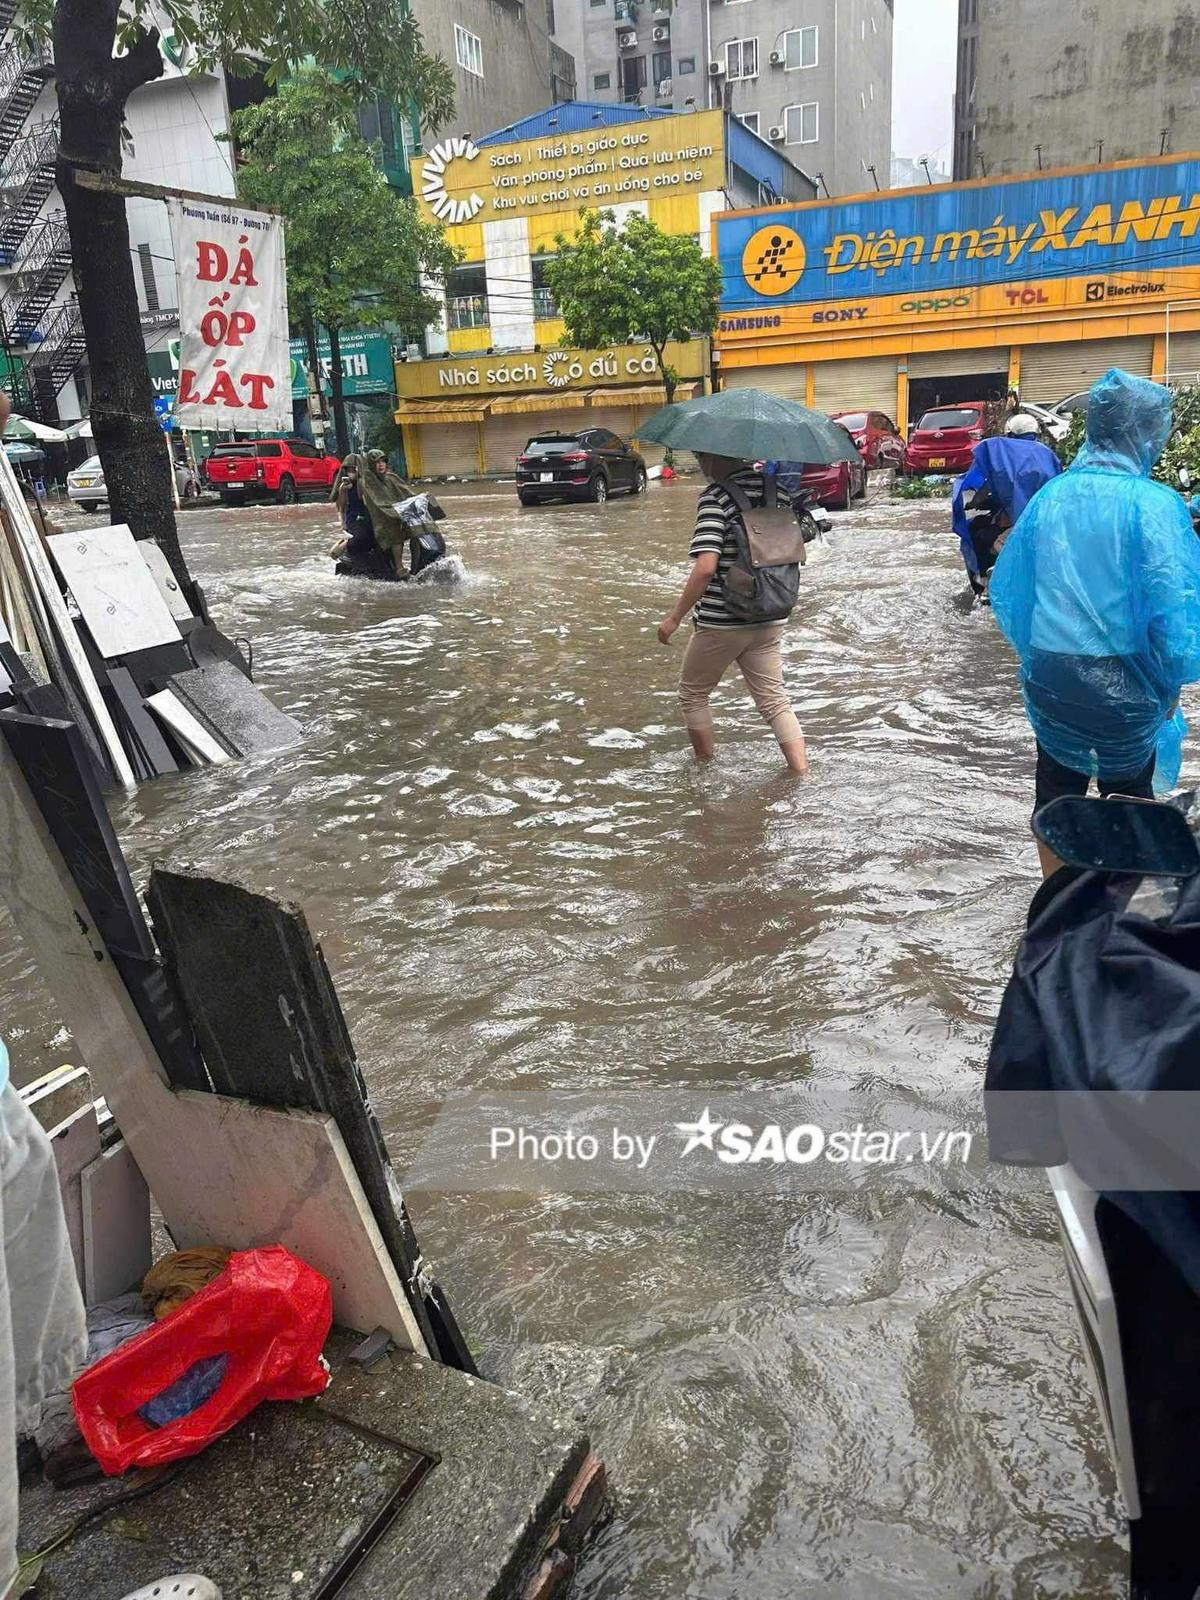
left=986, top=795, right=1200, bottom=1600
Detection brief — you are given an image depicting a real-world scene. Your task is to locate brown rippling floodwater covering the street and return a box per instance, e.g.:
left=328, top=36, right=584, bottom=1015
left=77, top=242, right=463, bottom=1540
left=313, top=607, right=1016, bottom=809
left=0, top=478, right=1145, bottom=1600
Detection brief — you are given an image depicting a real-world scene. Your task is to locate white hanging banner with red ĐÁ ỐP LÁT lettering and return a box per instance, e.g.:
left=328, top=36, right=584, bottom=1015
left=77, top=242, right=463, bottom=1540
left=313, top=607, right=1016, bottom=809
left=166, top=200, right=291, bottom=434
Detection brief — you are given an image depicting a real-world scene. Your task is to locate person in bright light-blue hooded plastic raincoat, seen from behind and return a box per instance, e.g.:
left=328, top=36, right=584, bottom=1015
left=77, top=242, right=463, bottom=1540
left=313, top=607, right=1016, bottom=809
left=990, top=368, right=1200, bottom=875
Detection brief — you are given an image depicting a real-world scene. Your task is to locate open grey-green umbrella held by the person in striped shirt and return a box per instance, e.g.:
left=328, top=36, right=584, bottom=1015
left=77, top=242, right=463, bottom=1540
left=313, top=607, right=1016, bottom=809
left=637, top=389, right=858, bottom=466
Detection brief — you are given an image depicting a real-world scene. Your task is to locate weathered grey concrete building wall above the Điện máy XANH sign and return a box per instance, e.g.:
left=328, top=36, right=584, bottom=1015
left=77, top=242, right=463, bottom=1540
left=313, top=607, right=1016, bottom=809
left=955, top=0, right=1200, bottom=178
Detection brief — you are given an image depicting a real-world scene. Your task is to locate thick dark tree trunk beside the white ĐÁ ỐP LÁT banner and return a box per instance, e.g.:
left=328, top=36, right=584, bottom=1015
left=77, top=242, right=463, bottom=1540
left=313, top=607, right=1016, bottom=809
left=54, top=0, right=192, bottom=592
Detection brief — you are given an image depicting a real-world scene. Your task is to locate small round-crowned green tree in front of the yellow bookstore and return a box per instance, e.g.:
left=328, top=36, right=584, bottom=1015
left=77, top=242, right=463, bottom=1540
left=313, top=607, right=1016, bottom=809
left=546, top=211, right=722, bottom=403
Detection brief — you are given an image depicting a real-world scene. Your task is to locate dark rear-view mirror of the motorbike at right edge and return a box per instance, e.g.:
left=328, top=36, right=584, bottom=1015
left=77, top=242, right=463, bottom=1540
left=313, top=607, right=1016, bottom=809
left=1034, top=795, right=1200, bottom=878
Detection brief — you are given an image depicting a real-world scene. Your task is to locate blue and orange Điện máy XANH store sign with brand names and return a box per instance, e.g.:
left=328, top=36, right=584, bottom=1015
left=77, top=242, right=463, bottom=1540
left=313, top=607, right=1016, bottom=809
left=717, top=157, right=1200, bottom=339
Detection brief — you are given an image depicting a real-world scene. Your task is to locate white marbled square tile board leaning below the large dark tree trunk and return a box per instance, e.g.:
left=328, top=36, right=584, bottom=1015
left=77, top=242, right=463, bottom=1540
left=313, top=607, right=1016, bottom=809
left=46, top=522, right=181, bottom=661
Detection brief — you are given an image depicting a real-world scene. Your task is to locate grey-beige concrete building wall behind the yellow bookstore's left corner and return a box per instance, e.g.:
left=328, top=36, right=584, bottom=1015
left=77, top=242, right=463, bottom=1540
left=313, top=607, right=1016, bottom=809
left=410, top=0, right=570, bottom=140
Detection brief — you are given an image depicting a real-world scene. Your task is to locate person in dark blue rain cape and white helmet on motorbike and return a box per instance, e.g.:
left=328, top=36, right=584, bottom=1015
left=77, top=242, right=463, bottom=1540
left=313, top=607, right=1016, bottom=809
left=950, top=413, right=1062, bottom=605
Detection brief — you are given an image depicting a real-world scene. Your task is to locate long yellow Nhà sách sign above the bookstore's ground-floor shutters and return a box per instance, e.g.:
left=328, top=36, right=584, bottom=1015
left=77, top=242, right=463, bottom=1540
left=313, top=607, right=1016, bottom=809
left=395, top=339, right=706, bottom=400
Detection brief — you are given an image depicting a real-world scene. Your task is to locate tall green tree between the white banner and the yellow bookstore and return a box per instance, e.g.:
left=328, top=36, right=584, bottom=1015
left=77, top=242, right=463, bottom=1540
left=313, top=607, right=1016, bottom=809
left=234, top=72, right=458, bottom=454
